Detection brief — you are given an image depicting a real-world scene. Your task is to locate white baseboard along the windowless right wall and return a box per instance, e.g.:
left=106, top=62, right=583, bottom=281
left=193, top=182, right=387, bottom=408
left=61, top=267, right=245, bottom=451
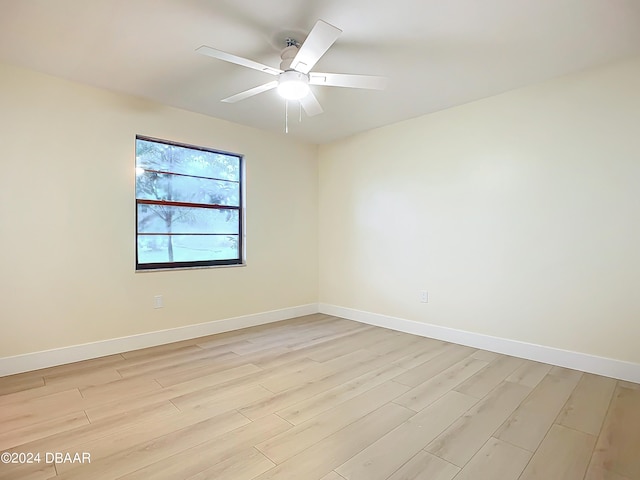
left=319, top=303, right=640, bottom=383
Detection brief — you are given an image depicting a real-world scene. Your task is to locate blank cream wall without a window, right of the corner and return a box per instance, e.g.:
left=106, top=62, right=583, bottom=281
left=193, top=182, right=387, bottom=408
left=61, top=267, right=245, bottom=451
left=319, top=58, right=640, bottom=363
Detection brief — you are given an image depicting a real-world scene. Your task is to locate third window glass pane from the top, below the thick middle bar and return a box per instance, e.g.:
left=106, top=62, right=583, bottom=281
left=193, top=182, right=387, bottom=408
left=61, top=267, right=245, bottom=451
left=138, top=205, right=240, bottom=235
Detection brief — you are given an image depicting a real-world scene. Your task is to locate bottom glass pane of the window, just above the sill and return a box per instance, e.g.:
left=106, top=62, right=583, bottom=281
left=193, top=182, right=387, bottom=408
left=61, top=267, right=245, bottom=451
left=138, top=235, right=240, bottom=264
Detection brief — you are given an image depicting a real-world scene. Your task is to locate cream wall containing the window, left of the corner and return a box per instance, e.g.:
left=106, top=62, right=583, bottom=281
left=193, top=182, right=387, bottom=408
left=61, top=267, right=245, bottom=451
left=0, top=65, right=318, bottom=357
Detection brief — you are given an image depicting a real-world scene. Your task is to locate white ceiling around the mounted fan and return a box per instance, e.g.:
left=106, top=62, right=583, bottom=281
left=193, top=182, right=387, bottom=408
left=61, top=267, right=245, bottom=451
left=0, top=0, right=640, bottom=143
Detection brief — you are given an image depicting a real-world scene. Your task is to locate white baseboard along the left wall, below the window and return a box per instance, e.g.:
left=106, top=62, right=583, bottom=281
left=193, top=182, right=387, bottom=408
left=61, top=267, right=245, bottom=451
left=0, top=303, right=318, bottom=377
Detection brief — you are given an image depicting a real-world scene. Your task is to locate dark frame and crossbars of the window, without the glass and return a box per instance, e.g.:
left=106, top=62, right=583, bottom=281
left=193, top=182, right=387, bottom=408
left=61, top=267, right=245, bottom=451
left=134, top=135, right=245, bottom=272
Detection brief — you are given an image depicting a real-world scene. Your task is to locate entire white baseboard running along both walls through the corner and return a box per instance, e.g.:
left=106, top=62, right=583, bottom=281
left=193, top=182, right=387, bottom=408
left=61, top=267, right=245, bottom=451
left=6, top=303, right=640, bottom=383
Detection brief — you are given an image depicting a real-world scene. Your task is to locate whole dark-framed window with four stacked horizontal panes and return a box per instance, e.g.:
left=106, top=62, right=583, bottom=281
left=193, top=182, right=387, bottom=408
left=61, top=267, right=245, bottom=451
left=136, top=136, right=242, bottom=270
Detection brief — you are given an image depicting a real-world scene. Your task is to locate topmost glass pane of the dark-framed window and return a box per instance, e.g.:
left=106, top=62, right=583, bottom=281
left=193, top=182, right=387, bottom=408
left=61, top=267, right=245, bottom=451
left=136, top=138, right=240, bottom=182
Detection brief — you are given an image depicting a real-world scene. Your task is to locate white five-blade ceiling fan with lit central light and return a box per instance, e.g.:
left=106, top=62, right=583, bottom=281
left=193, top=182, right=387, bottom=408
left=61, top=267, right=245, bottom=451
left=196, top=20, right=387, bottom=116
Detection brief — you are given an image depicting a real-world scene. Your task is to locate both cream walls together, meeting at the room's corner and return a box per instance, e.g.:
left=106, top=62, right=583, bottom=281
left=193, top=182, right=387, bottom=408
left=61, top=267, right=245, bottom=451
left=0, top=55, right=640, bottom=363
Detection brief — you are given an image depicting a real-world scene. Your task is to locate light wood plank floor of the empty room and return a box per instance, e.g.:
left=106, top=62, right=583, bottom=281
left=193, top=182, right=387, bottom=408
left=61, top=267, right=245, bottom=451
left=0, top=315, right=640, bottom=480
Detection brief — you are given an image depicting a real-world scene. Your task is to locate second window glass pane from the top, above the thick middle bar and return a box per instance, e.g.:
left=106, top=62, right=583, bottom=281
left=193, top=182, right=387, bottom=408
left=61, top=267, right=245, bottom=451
left=136, top=172, right=240, bottom=207
